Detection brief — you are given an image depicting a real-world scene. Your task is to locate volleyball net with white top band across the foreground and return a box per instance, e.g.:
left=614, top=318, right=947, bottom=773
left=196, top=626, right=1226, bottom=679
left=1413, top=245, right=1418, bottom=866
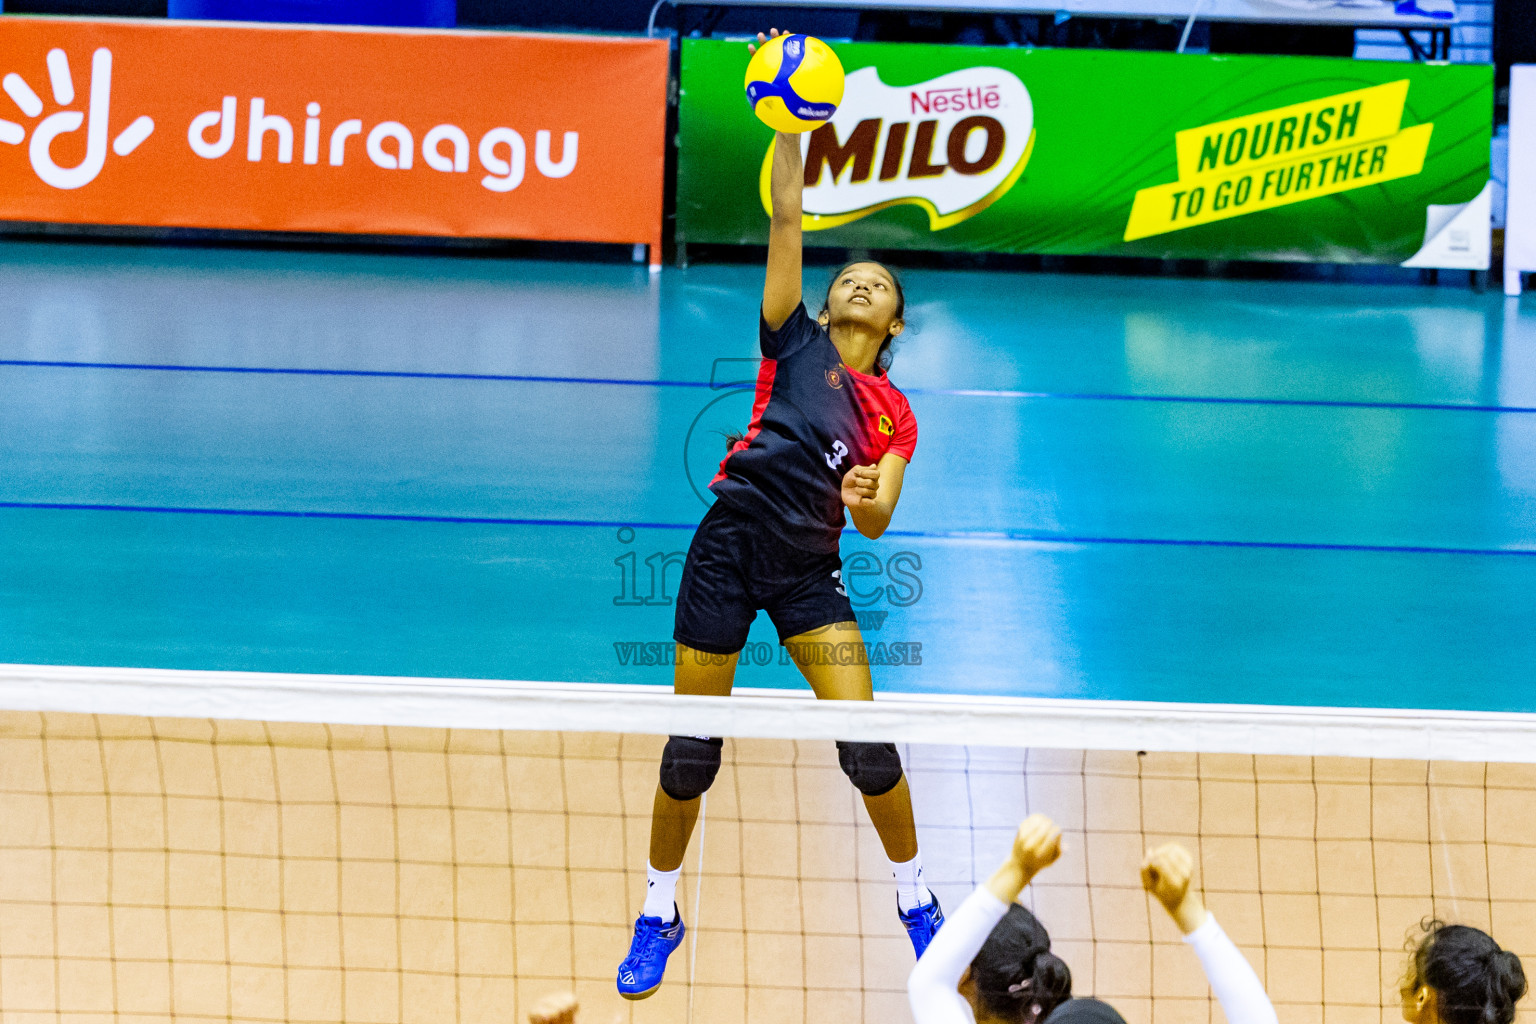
left=0, top=668, right=1536, bottom=1024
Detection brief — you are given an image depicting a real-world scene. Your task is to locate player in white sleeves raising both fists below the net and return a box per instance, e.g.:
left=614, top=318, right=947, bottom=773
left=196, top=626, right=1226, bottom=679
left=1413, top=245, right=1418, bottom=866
left=906, top=814, right=1284, bottom=1024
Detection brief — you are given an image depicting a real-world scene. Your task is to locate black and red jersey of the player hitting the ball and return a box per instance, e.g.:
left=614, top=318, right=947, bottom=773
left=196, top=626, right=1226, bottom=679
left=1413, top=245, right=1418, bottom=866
left=710, top=302, right=917, bottom=551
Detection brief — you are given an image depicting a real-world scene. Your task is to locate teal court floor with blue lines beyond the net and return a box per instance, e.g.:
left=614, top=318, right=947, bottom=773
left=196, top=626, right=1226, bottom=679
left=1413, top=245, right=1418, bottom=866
left=0, top=243, right=1536, bottom=711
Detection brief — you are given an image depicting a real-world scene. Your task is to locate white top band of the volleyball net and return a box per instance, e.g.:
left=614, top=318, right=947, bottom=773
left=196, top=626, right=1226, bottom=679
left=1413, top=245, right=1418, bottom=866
left=0, top=665, right=1536, bottom=763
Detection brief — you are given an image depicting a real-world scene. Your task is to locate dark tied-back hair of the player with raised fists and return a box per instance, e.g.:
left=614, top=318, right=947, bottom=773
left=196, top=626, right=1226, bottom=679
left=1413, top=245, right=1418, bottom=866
left=971, top=903, right=1072, bottom=1024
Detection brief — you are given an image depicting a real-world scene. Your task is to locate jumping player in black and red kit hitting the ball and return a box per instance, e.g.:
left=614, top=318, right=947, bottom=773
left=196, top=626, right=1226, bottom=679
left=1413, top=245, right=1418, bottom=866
left=617, top=31, right=943, bottom=999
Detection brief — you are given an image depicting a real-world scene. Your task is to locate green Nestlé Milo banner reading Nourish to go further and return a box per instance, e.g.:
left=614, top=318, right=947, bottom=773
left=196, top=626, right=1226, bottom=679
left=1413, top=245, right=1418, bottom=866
left=677, top=40, right=1493, bottom=266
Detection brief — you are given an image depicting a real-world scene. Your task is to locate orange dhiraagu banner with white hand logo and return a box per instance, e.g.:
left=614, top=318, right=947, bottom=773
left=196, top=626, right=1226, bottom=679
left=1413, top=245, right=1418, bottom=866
left=0, top=15, right=667, bottom=263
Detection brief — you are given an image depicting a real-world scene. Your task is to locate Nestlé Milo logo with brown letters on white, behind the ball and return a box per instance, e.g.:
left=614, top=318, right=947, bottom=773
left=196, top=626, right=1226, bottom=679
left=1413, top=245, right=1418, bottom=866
left=760, top=68, right=1034, bottom=230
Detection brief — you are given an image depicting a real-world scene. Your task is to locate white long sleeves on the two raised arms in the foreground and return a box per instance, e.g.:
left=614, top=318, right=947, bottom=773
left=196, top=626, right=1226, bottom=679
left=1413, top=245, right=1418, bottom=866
left=906, top=886, right=1279, bottom=1024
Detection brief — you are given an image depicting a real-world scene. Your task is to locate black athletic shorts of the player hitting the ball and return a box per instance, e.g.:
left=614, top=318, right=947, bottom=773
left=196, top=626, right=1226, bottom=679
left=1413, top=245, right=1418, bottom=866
left=673, top=500, right=854, bottom=654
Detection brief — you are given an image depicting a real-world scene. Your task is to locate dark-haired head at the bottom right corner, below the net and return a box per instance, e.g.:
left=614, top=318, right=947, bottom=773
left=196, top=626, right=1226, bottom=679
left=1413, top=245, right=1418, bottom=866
left=1413, top=921, right=1525, bottom=1024
